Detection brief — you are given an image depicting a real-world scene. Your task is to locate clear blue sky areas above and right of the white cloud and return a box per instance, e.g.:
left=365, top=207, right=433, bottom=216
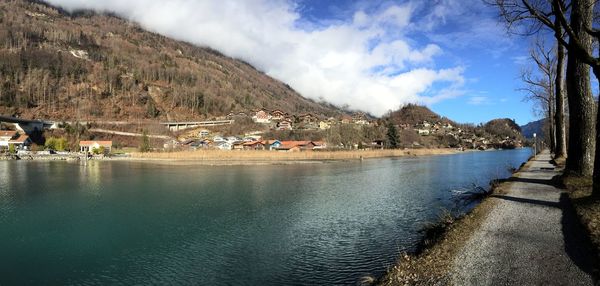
left=297, top=0, right=539, bottom=125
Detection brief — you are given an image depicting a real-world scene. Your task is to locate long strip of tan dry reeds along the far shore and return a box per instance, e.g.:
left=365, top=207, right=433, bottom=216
left=126, top=149, right=457, bottom=162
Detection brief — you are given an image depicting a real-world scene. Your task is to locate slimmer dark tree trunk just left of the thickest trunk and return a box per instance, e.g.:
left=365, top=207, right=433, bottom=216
left=554, top=28, right=567, bottom=158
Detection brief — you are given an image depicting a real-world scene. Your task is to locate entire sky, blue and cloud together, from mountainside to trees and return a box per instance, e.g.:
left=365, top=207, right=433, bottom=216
left=46, top=0, right=536, bottom=124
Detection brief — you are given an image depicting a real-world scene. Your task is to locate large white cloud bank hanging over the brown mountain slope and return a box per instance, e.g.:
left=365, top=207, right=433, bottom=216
left=46, top=0, right=464, bottom=115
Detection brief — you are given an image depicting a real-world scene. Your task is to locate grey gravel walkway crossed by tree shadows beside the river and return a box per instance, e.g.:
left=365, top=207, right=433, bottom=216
left=451, top=152, right=594, bottom=285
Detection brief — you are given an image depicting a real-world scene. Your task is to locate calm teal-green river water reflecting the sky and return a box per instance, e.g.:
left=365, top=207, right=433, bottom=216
left=0, top=149, right=531, bottom=285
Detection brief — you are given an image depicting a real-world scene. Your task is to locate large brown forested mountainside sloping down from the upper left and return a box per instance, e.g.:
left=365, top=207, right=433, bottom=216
left=0, top=0, right=341, bottom=121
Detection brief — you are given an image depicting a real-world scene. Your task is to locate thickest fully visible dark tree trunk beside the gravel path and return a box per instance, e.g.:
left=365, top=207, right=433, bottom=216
left=565, top=0, right=596, bottom=176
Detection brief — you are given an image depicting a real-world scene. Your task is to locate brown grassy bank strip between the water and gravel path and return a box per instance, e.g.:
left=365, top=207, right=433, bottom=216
left=376, top=153, right=534, bottom=286
